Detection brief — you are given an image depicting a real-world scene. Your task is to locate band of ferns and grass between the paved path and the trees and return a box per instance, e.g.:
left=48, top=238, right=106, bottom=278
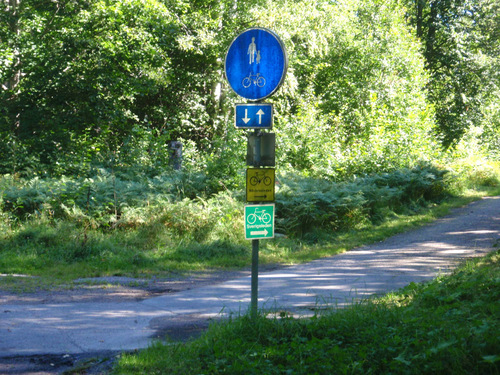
left=0, top=165, right=499, bottom=289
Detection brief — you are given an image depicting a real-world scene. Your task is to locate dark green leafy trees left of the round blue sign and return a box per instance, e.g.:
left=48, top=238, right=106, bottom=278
left=0, top=0, right=262, bottom=176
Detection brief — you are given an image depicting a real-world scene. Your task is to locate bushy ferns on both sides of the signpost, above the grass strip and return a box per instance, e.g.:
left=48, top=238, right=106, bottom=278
left=1, top=165, right=447, bottom=242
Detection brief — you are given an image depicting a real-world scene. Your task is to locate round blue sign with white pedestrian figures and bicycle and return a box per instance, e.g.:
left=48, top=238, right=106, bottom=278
left=225, top=28, right=288, bottom=100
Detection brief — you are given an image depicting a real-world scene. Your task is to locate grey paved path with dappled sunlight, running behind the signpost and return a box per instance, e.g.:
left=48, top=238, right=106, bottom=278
left=0, top=197, right=500, bottom=357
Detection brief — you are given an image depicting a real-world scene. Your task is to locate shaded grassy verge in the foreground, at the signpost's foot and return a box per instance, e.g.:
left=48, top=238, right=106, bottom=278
left=114, top=251, right=500, bottom=375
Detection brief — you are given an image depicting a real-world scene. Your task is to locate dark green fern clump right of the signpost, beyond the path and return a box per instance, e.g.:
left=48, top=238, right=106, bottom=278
left=276, top=165, right=447, bottom=235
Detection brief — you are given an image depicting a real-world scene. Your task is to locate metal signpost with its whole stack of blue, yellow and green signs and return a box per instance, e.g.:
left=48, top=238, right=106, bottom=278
left=224, top=28, right=288, bottom=319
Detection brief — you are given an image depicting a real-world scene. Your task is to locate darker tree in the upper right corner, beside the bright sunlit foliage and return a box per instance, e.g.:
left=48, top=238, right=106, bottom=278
left=408, top=0, right=500, bottom=148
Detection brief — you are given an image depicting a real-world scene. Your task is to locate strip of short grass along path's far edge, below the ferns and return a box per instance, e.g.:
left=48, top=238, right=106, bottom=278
left=0, top=187, right=500, bottom=291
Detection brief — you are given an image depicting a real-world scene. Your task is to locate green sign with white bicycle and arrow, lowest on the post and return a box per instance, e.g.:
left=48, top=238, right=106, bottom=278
left=245, top=203, right=274, bottom=240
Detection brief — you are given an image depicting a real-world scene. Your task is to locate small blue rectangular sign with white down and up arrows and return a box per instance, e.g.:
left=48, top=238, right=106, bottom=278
left=234, top=103, right=273, bottom=129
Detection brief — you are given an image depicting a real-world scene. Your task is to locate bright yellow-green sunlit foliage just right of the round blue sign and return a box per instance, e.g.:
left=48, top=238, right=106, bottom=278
left=249, top=0, right=436, bottom=177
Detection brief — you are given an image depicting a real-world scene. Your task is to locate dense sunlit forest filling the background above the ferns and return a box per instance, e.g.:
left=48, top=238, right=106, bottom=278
left=0, top=0, right=500, bottom=182
